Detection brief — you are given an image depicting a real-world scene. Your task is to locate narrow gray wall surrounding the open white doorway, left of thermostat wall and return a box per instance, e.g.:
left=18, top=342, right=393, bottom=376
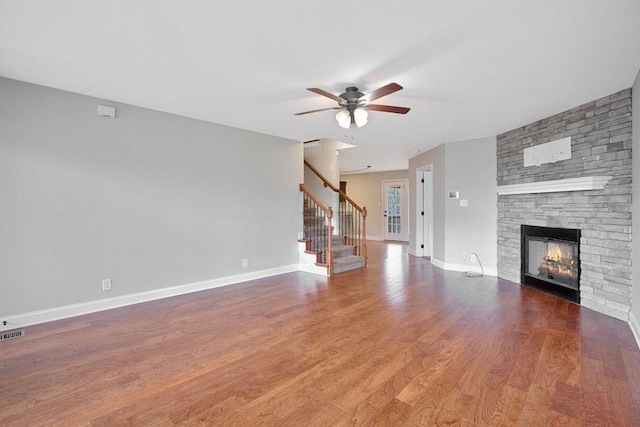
left=409, top=145, right=445, bottom=260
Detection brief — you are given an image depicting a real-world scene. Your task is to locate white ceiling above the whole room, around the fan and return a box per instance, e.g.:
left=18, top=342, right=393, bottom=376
left=0, top=0, right=640, bottom=172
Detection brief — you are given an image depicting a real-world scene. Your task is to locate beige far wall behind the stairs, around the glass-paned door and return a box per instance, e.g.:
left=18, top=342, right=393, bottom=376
left=340, top=170, right=413, bottom=240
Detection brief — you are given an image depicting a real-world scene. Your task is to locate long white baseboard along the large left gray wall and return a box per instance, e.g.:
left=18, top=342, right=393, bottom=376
left=0, top=264, right=300, bottom=331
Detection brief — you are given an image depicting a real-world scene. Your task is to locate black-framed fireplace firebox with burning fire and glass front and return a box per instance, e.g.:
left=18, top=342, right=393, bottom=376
left=520, top=225, right=580, bottom=303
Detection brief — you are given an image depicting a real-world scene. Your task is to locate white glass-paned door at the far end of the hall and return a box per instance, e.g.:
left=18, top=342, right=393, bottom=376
left=383, top=181, right=409, bottom=241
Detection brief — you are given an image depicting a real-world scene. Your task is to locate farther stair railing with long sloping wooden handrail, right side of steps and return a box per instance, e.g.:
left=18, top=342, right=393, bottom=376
left=304, top=160, right=367, bottom=265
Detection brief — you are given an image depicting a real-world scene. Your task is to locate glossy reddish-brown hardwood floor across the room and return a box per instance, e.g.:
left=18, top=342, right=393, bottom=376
left=0, top=242, right=640, bottom=426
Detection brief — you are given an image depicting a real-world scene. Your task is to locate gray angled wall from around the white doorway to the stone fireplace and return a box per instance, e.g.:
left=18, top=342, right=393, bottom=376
left=409, top=137, right=497, bottom=275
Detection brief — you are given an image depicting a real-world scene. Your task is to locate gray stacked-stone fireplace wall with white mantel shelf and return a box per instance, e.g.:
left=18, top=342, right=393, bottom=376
left=497, top=89, right=632, bottom=320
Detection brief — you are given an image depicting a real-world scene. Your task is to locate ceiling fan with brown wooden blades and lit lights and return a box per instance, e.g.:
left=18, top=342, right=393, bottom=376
left=295, top=83, right=410, bottom=129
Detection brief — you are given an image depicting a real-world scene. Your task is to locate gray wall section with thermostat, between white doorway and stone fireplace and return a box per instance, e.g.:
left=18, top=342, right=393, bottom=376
left=444, top=137, right=498, bottom=275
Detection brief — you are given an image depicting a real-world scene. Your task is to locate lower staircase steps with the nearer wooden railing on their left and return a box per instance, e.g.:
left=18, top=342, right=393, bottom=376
left=299, top=202, right=366, bottom=276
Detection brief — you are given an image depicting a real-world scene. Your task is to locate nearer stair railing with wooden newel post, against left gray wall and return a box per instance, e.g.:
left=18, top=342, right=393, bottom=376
left=300, top=184, right=333, bottom=276
